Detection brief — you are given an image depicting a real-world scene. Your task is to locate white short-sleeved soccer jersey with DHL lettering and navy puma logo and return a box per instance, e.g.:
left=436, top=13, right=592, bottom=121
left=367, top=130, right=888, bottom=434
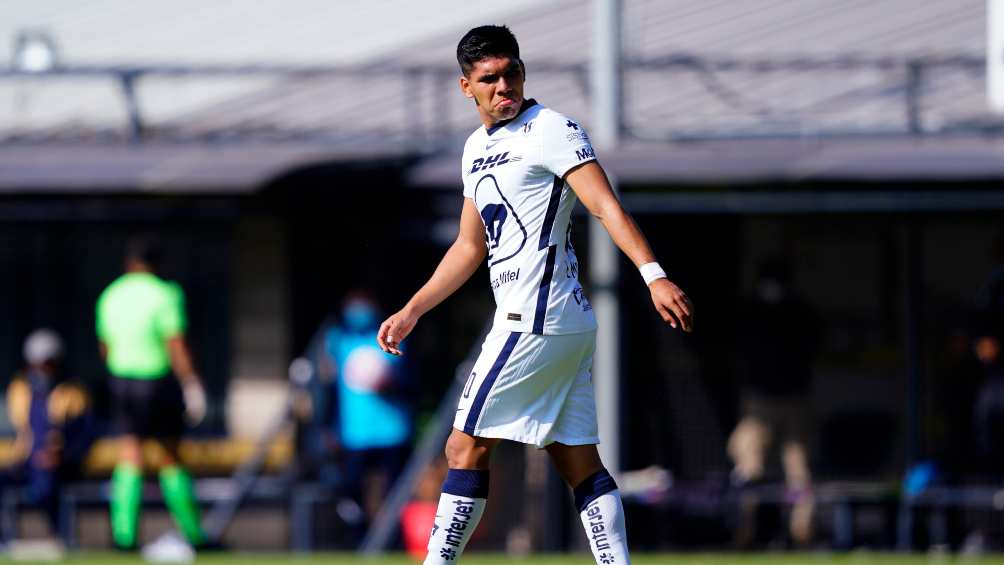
left=463, top=99, right=596, bottom=335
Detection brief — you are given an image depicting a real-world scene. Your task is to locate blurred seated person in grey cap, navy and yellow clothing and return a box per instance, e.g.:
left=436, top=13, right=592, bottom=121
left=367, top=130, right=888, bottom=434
left=3, top=329, right=94, bottom=534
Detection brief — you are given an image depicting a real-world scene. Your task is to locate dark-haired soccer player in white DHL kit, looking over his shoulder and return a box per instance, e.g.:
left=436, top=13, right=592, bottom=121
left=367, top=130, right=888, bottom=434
left=378, top=26, right=692, bottom=565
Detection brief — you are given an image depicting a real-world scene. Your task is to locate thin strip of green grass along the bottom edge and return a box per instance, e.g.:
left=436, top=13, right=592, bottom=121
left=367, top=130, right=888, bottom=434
left=0, top=552, right=1004, bottom=565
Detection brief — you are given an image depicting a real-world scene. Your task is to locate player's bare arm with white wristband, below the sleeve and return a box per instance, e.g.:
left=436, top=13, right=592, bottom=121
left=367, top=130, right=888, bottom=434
left=565, top=161, right=694, bottom=331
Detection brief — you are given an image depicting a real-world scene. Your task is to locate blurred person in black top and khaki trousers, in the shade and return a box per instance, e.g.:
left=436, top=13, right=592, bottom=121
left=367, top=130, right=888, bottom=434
left=728, top=259, right=820, bottom=546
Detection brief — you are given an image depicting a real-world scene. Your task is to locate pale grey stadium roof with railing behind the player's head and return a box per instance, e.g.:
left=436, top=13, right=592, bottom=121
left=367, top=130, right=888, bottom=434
left=0, top=0, right=1004, bottom=193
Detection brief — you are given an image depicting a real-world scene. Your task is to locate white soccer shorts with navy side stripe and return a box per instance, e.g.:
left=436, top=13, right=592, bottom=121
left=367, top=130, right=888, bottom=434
left=453, top=330, right=599, bottom=448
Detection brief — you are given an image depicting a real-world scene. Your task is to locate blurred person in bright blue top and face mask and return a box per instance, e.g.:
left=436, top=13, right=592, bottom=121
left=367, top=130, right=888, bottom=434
left=321, top=291, right=413, bottom=537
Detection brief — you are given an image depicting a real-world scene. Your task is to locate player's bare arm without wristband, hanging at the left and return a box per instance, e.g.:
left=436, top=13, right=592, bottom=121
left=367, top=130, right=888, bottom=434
left=377, top=198, right=488, bottom=355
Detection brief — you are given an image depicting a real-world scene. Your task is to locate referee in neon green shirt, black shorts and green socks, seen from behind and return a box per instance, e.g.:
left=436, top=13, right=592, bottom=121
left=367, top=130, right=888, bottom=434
left=96, top=237, right=206, bottom=549
